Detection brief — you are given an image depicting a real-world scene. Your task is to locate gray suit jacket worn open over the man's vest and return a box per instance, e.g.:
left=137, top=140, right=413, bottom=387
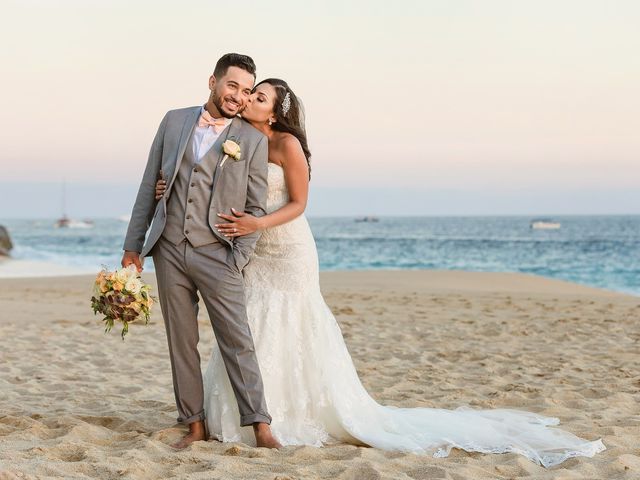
left=123, top=107, right=269, bottom=269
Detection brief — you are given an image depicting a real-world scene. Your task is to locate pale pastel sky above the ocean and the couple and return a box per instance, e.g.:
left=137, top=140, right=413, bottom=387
left=0, top=0, right=640, bottom=217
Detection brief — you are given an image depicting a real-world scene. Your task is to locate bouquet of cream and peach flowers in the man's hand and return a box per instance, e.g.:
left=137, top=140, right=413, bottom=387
left=91, top=265, right=153, bottom=340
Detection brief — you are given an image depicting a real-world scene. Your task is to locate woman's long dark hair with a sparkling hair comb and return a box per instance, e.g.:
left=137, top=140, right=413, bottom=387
left=256, top=78, right=311, bottom=179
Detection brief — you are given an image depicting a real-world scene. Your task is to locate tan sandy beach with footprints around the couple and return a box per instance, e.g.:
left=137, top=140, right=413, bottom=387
left=0, top=271, right=640, bottom=480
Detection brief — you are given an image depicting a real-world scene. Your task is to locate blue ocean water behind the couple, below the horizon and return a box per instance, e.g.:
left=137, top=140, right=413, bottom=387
left=0, top=216, right=640, bottom=295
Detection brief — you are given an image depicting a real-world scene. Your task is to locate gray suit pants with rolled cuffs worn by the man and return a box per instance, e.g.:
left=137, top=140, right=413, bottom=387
left=151, top=237, right=271, bottom=426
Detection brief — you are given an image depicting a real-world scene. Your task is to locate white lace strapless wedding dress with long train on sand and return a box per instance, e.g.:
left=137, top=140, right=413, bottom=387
left=204, top=163, right=605, bottom=467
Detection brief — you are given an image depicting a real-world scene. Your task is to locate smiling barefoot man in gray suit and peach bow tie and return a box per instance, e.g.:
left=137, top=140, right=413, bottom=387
left=122, top=53, right=280, bottom=448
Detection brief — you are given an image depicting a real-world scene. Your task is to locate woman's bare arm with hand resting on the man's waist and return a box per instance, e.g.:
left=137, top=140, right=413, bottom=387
left=216, top=136, right=309, bottom=237
